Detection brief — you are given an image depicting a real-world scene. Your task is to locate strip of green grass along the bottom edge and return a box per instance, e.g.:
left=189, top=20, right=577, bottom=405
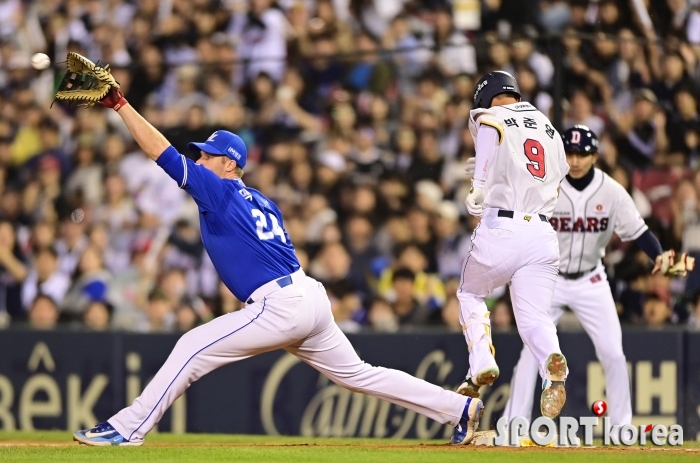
left=0, top=431, right=700, bottom=463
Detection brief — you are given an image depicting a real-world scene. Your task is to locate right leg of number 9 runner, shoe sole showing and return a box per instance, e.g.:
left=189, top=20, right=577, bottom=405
left=510, top=232, right=567, bottom=418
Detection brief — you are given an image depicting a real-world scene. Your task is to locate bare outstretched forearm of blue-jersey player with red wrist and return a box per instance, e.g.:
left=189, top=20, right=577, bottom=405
left=100, top=87, right=170, bottom=161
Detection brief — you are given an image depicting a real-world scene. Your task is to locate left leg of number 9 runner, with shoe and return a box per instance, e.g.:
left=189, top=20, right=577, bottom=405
left=457, top=223, right=521, bottom=390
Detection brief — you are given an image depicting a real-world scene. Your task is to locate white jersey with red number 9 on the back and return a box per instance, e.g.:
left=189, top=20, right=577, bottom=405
left=469, top=102, right=569, bottom=217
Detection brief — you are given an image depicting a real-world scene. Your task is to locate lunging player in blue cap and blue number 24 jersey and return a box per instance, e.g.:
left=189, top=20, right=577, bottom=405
left=73, top=87, right=483, bottom=446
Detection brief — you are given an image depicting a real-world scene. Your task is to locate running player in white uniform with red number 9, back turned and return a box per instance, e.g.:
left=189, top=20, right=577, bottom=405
left=457, top=71, right=569, bottom=418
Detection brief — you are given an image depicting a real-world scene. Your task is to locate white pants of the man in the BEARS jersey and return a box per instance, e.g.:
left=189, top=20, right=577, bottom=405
left=504, top=265, right=632, bottom=434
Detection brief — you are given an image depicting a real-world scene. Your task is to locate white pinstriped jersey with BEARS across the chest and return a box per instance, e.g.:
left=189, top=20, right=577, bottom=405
left=550, top=169, right=647, bottom=273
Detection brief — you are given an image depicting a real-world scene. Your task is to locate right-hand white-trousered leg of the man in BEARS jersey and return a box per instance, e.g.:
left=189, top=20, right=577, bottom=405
left=571, top=269, right=632, bottom=432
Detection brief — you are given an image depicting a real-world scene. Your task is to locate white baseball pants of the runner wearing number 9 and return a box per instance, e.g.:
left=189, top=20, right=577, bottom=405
left=457, top=208, right=561, bottom=378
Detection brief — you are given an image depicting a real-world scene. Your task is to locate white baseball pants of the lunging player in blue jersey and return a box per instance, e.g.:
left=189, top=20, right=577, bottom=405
left=108, top=270, right=467, bottom=441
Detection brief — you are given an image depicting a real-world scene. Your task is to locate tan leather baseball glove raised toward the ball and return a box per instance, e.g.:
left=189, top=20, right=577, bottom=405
left=56, top=52, right=119, bottom=108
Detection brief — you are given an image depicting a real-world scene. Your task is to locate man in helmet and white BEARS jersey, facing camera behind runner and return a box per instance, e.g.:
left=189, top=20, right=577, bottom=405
left=504, top=125, right=693, bottom=436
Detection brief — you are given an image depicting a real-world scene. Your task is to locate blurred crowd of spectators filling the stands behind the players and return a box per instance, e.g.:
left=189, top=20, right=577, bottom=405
left=0, top=0, right=700, bottom=332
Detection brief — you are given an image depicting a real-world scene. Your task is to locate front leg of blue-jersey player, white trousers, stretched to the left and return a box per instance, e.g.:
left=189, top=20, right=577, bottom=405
left=88, top=283, right=313, bottom=442
